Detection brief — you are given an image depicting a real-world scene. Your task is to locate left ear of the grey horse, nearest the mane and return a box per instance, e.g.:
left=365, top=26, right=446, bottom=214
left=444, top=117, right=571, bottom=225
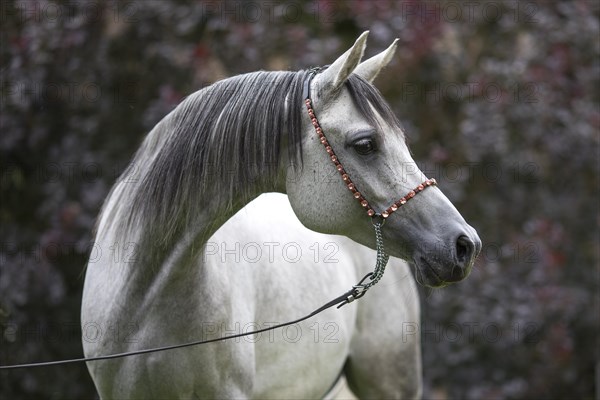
left=314, top=31, right=369, bottom=97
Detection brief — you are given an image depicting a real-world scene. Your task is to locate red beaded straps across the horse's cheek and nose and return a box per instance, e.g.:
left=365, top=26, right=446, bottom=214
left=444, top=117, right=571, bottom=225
left=304, top=98, right=437, bottom=219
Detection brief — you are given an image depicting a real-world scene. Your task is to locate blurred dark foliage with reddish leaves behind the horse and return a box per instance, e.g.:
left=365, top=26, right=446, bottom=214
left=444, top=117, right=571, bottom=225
left=0, top=0, right=600, bottom=399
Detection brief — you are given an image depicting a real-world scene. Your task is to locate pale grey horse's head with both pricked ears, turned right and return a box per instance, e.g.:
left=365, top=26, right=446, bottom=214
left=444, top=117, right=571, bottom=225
left=286, top=32, right=481, bottom=287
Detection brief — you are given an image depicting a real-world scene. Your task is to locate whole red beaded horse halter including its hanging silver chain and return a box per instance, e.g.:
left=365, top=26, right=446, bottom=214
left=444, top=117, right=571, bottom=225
left=303, top=67, right=437, bottom=296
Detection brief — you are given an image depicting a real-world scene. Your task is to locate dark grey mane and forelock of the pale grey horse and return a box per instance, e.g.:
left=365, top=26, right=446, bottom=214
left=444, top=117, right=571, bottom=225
left=99, top=71, right=401, bottom=253
